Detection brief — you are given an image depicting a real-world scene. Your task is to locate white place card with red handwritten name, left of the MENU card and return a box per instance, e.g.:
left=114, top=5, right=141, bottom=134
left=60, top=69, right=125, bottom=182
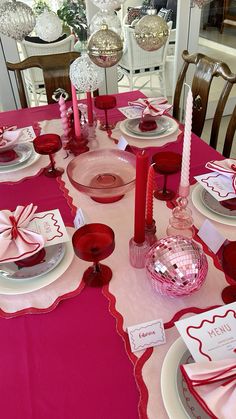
left=127, top=319, right=166, bottom=352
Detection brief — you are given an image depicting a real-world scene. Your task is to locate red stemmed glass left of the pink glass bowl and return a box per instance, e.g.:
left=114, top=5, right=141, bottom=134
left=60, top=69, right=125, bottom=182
left=33, top=134, right=64, bottom=177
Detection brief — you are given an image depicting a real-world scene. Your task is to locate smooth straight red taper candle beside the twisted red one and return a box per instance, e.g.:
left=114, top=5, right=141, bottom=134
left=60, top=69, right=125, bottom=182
left=134, top=150, right=148, bottom=243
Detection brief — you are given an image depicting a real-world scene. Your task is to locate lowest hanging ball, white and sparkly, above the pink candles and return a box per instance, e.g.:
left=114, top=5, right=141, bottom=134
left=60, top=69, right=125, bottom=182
left=70, top=54, right=104, bottom=93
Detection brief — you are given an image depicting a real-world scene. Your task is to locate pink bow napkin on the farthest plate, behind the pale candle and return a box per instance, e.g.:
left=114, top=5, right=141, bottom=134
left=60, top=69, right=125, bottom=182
left=128, top=97, right=172, bottom=116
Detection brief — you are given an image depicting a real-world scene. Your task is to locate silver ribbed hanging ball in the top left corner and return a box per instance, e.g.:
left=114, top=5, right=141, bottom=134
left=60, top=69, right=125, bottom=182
left=0, top=0, right=35, bottom=41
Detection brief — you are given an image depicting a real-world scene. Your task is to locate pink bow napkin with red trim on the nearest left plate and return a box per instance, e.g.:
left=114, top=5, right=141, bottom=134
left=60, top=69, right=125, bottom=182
left=0, top=204, right=44, bottom=263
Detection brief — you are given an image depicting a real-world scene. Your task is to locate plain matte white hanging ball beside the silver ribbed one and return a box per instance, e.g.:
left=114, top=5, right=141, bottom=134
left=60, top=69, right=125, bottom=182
left=35, top=10, right=62, bottom=42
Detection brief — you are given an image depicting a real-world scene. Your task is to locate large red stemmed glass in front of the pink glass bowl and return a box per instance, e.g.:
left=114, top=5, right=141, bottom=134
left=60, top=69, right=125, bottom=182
left=72, top=223, right=115, bottom=287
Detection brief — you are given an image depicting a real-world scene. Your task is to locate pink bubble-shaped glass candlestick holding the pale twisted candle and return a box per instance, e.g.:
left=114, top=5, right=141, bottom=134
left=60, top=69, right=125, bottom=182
left=166, top=196, right=194, bottom=238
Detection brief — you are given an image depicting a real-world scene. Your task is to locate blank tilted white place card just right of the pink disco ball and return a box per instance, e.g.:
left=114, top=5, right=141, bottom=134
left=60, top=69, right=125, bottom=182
left=198, top=220, right=226, bottom=253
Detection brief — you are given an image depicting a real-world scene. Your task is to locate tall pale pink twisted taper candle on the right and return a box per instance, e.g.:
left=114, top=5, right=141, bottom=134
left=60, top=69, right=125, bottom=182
left=179, top=86, right=193, bottom=197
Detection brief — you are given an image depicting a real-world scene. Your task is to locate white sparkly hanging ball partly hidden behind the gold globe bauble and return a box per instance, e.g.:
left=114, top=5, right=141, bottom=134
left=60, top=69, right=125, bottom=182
left=89, top=10, right=121, bottom=35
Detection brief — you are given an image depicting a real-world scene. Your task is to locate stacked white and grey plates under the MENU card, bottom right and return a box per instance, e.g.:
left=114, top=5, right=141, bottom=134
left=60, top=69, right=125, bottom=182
left=161, top=338, right=210, bottom=419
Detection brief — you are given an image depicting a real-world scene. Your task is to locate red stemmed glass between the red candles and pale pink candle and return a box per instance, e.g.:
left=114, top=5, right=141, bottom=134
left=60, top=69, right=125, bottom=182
left=152, top=151, right=182, bottom=201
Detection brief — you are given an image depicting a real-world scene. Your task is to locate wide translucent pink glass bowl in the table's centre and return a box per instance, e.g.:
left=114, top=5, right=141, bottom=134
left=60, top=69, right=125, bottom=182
left=67, top=149, right=136, bottom=203
